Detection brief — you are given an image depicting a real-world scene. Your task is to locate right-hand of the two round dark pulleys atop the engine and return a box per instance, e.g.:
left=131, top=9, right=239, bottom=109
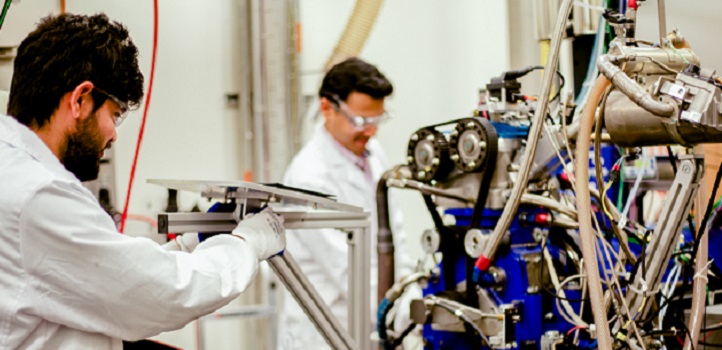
left=449, top=118, right=489, bottom=172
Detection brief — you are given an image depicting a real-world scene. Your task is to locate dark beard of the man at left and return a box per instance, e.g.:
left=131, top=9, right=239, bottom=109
left=63, top=113, right=110, bottom=182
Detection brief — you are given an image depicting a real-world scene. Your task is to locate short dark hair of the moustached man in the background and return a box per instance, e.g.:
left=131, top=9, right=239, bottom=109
left=318, top=57, right=394, bottom=101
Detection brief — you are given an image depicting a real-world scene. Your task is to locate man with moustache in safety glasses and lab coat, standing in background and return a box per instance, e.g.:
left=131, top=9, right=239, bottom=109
left=279, top=58, right=411, bottom=350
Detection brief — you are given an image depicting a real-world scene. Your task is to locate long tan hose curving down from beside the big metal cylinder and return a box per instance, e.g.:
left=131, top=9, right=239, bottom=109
left=575, top=75, right=612, bottom=349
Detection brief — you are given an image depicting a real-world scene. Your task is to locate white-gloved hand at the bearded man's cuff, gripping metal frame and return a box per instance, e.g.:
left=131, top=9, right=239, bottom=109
left=231, top=208, right=286, bottom=260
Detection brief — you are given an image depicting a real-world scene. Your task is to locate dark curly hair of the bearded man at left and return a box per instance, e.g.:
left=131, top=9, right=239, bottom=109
left=7, top=14, right=143, bottom=128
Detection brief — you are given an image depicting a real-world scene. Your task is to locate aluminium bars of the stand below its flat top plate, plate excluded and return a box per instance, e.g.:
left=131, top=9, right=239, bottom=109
left=158, top=209, right=371, bottom=349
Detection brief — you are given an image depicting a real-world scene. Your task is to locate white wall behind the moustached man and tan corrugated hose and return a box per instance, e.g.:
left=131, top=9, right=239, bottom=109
left=300, top=0, right=509, bottom=258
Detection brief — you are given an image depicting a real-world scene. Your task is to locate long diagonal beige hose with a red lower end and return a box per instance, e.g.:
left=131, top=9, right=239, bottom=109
left=476, top=0, right=573, bottom=270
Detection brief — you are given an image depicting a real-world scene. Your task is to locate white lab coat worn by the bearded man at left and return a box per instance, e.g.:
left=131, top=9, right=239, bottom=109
left=0, top=115, right=258, bottom=350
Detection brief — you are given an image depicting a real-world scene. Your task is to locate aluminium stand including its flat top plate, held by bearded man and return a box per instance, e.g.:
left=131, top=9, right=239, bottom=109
left=151, top=180, right=371, bottom=350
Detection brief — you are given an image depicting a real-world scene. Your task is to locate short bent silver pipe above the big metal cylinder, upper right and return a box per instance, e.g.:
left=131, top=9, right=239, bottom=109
left=597, top=55, right=677, bottom=117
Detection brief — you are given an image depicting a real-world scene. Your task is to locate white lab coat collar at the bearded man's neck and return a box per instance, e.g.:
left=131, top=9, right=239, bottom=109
left=0, top=114, right=77, bottom=181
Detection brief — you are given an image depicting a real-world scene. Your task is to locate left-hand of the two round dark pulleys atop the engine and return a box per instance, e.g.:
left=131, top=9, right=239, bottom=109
left=407, top=128, right=453, bottom=182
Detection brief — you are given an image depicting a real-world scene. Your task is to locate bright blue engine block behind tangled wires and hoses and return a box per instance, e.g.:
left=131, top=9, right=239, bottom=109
left=423, top=144, right=620, bottom=350
